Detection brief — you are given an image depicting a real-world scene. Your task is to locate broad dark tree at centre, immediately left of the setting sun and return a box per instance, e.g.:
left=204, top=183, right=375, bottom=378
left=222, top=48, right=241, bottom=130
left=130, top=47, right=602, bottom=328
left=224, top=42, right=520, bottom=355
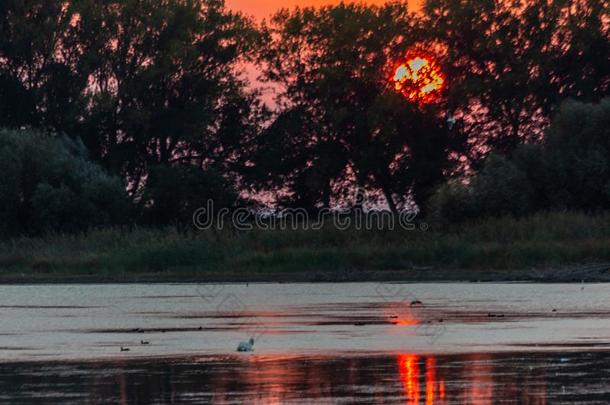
left=250, top=3, right=459, bottom=209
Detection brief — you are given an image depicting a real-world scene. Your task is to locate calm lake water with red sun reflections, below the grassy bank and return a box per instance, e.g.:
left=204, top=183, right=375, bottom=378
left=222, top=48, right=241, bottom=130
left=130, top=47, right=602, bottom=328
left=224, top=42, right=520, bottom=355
left=0, top=283, right=610, bottom=404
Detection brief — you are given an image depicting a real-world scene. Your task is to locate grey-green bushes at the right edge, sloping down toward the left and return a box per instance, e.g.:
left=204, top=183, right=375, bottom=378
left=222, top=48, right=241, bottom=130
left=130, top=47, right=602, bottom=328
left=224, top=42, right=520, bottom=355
left=430, top=99, right=610, bottom=223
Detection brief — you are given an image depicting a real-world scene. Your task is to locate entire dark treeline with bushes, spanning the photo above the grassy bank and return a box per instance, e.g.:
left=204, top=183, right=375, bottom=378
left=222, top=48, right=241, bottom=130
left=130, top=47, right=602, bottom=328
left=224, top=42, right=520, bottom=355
left=0, top=0, right=610, bottom=234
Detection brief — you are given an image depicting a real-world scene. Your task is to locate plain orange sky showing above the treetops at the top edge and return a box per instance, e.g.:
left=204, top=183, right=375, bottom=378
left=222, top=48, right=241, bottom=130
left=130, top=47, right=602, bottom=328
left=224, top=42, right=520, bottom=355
left=227, top=0, right=422, bottom=20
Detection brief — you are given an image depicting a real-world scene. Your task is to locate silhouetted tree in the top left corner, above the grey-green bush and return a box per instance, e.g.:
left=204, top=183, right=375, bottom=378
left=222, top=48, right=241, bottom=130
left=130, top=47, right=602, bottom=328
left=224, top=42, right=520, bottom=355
left=0, top=0, right=87, bottom=132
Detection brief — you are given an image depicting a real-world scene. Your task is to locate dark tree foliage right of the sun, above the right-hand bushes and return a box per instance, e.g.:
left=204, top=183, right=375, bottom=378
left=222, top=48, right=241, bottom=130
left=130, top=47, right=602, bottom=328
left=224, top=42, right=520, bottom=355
left=419, top=0, right=610, bottom=159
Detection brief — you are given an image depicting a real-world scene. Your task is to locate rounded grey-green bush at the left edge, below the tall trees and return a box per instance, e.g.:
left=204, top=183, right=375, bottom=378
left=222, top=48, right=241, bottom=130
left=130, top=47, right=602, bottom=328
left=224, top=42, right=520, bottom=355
left=0, top=130, right=128, bottom=236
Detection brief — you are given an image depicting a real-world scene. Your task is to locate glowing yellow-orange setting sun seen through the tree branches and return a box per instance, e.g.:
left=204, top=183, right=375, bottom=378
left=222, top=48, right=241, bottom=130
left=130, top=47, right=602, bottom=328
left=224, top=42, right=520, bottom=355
left=392, top=52, right=446, bottom=103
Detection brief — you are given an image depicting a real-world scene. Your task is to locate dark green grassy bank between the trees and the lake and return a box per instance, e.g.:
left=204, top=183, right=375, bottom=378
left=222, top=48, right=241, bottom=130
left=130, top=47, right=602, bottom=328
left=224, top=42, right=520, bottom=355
left=0, top=213, right=610, bottom=282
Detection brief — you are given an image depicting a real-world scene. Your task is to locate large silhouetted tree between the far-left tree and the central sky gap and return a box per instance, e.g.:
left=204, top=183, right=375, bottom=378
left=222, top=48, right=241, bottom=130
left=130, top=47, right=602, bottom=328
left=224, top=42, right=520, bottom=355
left=73, top=0, right=259, bottom=192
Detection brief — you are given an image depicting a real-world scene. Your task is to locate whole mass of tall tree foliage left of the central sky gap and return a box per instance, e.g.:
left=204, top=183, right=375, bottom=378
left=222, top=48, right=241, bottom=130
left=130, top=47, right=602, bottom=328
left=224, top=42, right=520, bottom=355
left=0, top=0, right=265, bottom=202
